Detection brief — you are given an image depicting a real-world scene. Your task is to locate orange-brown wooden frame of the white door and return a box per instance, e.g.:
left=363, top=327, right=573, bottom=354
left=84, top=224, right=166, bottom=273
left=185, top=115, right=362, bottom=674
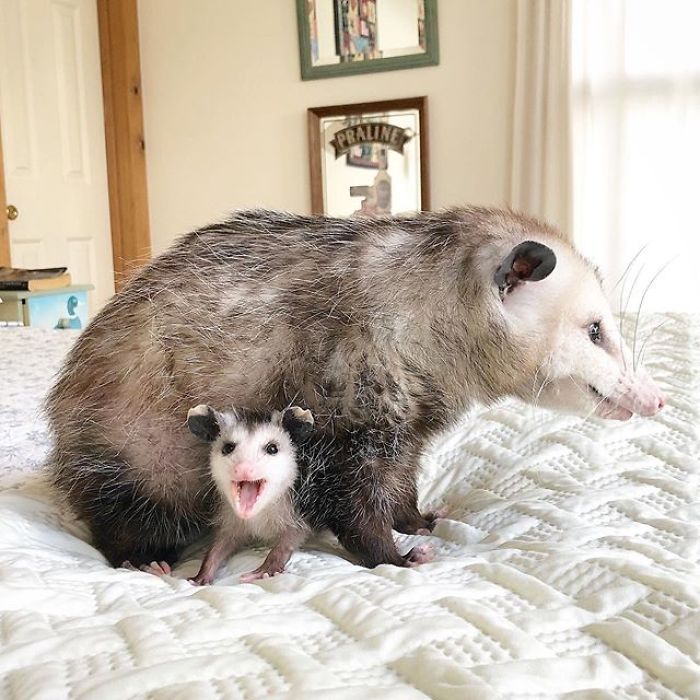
left=0, top=0, right=151, bottom=290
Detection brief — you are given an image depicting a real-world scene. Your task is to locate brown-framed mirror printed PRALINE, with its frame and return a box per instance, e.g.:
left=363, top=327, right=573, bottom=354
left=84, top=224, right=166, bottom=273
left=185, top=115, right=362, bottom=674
left=308, top=97, right=430, bottom=217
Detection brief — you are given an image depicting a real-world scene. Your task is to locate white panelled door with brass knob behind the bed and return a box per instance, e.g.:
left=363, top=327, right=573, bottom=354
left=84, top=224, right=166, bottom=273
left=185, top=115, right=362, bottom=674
left=0, top=0, right=114, bottom=312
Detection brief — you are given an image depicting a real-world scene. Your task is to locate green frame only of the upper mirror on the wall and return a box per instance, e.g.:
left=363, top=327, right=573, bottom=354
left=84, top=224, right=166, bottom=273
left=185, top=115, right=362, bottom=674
left=296, top=0, right=440, bottom=80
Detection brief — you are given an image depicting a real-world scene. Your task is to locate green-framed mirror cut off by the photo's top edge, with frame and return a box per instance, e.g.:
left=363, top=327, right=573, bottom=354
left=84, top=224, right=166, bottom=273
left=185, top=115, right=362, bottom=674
left=297, top=0, right=439, bottom=80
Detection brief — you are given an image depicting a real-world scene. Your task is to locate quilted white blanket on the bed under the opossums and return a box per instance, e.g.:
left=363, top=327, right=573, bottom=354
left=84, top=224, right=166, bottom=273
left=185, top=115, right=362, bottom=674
left=0, top=317, right=700, bottom=700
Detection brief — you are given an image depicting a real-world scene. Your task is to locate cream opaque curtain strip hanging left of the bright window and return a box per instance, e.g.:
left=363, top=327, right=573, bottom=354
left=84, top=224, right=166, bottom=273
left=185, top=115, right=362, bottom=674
left=511, top=0, right=571, bottom=235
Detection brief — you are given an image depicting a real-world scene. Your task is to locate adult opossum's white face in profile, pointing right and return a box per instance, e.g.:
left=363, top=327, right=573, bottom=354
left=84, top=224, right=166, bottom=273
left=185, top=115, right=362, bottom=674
left=494, top=241, right=665, bottom=420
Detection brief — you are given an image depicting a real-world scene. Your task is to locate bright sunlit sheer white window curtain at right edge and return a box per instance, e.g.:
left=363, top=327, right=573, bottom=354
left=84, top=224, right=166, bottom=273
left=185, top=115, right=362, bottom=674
left=571, top=0, right=700, bottom=311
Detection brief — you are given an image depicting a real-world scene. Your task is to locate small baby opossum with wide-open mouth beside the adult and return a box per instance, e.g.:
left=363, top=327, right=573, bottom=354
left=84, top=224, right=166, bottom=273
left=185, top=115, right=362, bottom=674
left=187, top=404, right=314, bottom=585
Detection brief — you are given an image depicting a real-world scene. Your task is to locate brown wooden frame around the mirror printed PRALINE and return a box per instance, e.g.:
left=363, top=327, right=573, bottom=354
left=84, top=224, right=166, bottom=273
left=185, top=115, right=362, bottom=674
left=307, top=96, right=430, bottom=214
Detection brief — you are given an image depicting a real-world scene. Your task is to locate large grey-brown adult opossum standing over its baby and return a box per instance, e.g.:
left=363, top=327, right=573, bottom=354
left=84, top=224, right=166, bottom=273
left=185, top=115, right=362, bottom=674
left=48, top=208, right=663, bottom=566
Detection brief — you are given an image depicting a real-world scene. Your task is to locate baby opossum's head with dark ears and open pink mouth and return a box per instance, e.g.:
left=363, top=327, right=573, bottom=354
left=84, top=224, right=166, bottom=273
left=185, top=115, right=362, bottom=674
left=187, top=404, right=313, bottom=520
